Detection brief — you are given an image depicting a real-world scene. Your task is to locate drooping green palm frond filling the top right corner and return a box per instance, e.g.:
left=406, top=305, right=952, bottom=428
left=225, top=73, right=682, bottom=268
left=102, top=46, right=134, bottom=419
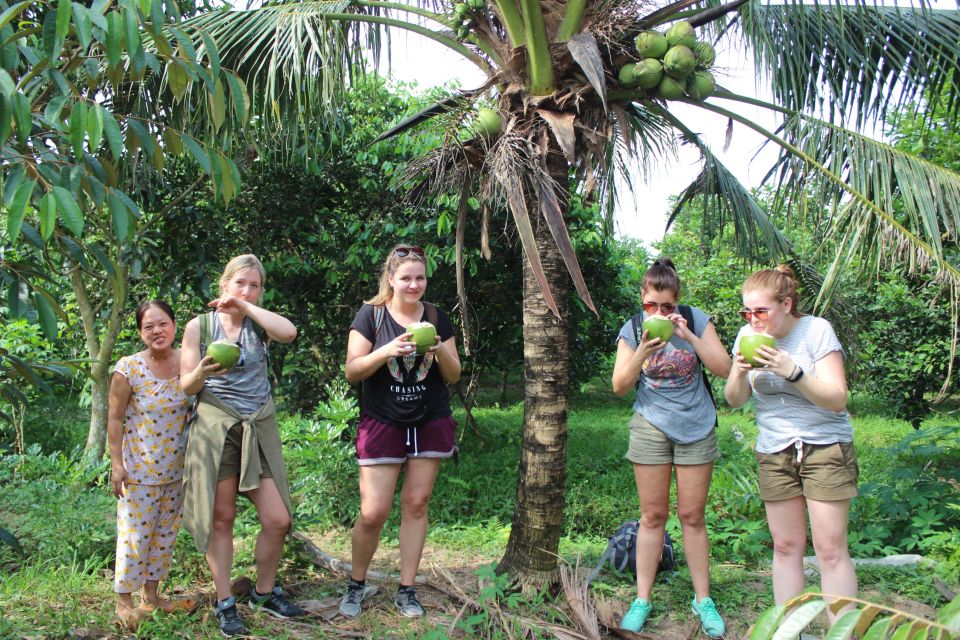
left=740, top=0, right=960, bottom=128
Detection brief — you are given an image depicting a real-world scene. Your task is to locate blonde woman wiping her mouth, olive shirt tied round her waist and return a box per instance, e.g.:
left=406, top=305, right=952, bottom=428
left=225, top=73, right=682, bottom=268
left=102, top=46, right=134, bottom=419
left=180, top=254, right=306, bottom=636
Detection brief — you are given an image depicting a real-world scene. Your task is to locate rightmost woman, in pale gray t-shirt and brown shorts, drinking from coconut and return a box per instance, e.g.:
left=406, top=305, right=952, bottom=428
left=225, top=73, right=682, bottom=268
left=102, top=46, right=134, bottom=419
left=725, top=265, right=858, bottom=620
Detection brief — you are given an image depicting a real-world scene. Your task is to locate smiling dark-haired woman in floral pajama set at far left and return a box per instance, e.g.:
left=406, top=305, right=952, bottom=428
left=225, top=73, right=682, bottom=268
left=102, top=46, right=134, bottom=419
left=107, top=300, right=189, bottom=624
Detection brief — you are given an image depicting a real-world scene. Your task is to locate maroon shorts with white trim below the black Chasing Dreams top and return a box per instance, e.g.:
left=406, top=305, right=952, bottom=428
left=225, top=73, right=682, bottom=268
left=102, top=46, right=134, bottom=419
left=357, top=415, right=457, bottom=465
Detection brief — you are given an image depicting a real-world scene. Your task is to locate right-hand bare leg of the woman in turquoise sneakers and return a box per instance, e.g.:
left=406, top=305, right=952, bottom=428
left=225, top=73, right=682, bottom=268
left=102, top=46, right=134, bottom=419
left=675, top=462, right=713, bottom=602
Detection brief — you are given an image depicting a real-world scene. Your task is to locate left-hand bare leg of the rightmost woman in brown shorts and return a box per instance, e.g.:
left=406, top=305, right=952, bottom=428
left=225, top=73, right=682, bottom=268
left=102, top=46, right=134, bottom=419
left=763, top=496, right=807, bottom=604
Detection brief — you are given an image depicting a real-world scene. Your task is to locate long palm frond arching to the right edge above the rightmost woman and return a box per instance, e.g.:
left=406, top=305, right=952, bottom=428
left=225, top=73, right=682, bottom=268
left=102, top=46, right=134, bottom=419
left=700, top=94, right=960, bottom=304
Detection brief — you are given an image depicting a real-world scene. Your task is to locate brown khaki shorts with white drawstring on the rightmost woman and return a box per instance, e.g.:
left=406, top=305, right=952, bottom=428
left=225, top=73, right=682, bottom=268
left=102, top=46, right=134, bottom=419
left=757, top=442, right=860, bottom=502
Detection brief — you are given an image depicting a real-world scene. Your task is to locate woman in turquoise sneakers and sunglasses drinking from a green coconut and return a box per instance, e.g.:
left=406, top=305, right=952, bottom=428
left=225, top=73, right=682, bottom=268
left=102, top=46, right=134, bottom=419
left=613, top=258, right=730, bottom=638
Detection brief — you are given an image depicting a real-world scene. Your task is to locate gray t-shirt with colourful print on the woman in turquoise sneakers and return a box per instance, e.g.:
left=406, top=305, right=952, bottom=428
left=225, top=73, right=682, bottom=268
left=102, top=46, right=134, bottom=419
left=617, top=307, right=717, bottom=444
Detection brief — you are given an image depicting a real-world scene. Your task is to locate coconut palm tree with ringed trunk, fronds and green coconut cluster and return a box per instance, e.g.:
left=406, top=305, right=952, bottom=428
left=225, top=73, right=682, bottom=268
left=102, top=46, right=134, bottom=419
left=183, top=0, right=960, bottom=585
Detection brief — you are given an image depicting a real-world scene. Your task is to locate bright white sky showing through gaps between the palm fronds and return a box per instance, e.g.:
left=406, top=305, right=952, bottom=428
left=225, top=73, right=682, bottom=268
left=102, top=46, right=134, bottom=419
left=384, top=32, right=777, bottom=246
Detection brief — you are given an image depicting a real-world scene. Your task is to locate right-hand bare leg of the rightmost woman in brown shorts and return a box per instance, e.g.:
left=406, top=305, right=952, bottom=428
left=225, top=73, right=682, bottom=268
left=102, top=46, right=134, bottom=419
left=807, top=499, right=857, bottom=623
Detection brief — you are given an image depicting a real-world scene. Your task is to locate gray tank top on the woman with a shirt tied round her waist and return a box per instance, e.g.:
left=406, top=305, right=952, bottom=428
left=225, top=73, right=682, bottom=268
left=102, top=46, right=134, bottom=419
left=200, top=311, right=270, bottom=415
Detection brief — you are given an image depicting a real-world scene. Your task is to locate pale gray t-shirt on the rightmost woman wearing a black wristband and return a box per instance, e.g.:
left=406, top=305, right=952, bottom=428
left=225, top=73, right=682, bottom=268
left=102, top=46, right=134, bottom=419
left=732, top=316, right=853, bottom=453
